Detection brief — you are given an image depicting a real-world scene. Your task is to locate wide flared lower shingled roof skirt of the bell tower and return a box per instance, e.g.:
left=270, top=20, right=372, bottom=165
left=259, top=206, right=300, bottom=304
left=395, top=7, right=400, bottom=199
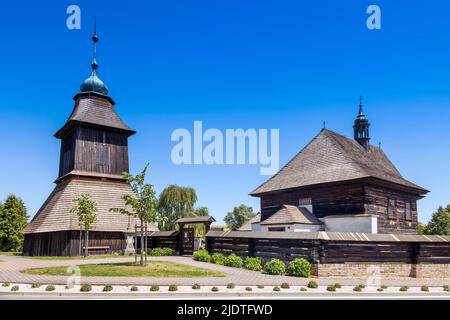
left=24, top=178, right=158, bottom=234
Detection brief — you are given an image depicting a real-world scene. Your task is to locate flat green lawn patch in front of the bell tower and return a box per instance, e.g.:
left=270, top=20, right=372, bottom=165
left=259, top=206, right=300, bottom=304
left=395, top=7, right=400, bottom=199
left=22, top=261, right=225, bottom=278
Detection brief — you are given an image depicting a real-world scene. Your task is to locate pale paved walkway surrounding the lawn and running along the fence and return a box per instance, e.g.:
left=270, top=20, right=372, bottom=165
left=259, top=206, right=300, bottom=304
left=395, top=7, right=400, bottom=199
left=0, top=256, right=450, bottom=287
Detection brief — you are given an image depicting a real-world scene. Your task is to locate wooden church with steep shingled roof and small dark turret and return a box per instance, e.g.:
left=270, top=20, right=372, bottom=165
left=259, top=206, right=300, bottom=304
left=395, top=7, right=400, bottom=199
left=250, top=101, right=428, bottom=234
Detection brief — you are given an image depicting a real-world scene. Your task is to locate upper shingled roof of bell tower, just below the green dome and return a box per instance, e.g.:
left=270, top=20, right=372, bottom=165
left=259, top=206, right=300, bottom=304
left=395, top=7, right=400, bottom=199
left=55, top=92, right=136, bottom=138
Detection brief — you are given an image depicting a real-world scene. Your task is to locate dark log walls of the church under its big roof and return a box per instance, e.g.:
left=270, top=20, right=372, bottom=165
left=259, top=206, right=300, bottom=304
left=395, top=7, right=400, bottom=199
left=261, top=180, right=419, bottom=234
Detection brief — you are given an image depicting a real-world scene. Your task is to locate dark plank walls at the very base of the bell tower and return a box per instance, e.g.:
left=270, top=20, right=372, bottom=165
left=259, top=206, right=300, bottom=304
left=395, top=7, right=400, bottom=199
left=23, top=231, right=125, bottom=256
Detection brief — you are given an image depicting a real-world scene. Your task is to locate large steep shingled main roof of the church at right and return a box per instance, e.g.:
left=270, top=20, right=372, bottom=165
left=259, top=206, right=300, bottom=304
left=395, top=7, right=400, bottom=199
left=250, top=129, right=428, bottom=195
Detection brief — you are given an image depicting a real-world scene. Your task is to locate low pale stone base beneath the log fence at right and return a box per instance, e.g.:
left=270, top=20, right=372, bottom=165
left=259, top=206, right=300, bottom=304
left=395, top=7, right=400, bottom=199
left=313, top=263, right=450, bottom=279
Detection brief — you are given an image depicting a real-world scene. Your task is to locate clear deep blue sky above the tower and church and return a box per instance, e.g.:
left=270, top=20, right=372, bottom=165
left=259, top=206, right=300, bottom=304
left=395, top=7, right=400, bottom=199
left=0, top=0, right=450, bottom=221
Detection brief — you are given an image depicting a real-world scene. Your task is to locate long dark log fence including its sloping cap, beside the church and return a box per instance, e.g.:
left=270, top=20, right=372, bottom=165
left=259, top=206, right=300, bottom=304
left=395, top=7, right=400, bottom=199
left=206, top=231, right=450, bottom=263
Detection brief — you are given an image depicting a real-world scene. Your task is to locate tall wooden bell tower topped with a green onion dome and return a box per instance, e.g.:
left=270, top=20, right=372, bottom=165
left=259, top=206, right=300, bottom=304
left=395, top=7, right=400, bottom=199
left=23, top=34, right=157, bottom=256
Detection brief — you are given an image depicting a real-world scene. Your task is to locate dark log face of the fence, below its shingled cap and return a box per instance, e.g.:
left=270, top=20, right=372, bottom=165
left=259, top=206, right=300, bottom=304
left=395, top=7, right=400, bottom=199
left=206, top=236, right=450, bottom=263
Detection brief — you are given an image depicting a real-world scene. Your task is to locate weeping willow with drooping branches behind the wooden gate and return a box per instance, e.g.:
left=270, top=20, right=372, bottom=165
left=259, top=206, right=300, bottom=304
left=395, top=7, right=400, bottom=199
left=158, top=184, right=197, bottom=231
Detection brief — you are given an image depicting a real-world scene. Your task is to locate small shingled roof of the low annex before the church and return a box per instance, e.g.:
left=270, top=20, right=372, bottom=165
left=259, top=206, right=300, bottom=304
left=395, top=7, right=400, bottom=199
left=261, top=204, right=322, bottom=225
